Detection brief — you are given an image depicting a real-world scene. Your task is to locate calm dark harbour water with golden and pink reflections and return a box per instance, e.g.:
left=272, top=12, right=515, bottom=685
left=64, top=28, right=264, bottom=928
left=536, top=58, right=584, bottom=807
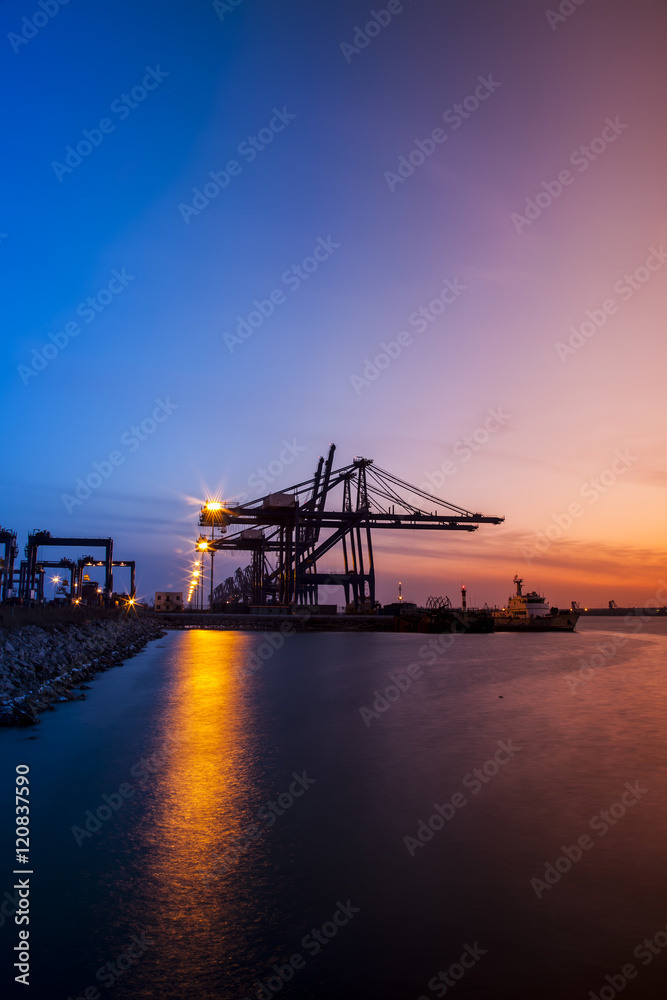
left=0, top=619, right=667, bottom=1000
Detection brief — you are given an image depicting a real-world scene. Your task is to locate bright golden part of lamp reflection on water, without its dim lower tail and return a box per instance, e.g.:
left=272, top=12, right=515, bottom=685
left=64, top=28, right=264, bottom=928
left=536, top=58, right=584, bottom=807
left=141, top=630, right=252, bottom=896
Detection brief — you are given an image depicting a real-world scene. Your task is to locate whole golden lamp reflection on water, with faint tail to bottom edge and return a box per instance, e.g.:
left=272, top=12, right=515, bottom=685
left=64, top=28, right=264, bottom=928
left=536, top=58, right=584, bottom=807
left=116, top=630, right=264, bottom=998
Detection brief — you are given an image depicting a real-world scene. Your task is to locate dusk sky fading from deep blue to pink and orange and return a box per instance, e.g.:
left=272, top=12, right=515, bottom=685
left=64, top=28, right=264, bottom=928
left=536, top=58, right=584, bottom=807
left=0, top=0, right=667, bottom=606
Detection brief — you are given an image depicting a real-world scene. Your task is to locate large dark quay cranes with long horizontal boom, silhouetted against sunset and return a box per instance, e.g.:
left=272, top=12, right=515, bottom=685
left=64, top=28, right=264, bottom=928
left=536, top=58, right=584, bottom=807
left=199, top=444, right=505, bottom=610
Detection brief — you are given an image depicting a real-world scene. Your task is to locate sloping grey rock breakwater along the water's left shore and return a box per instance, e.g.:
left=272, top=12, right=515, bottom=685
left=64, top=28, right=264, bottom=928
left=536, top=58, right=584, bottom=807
left=0, top=617, right=166, bottom=726
